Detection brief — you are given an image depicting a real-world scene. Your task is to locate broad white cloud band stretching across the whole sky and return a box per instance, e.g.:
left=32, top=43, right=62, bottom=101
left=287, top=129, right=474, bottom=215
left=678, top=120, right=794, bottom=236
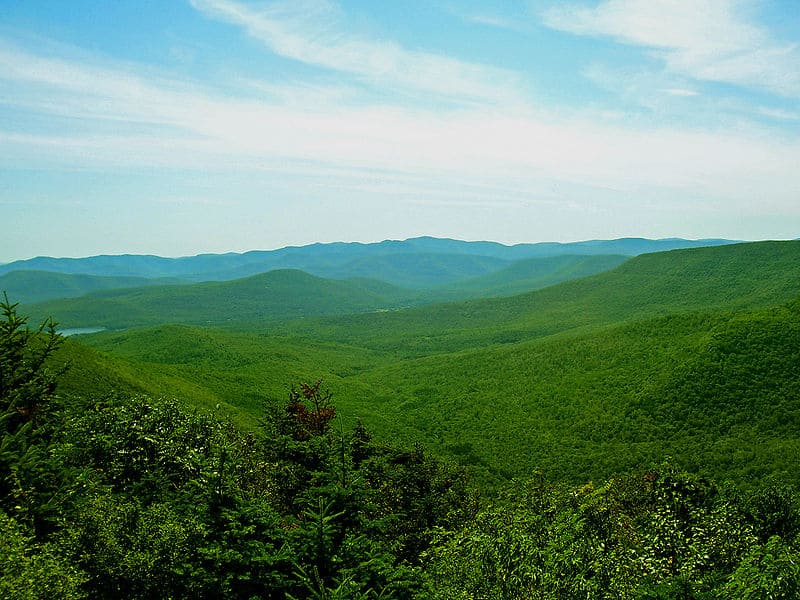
left=0, top=37, right=800, bottom=207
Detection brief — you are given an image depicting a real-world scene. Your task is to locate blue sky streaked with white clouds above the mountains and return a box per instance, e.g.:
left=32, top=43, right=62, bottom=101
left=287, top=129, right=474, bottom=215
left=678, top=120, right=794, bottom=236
left=0, top=0, right=800, bottom=262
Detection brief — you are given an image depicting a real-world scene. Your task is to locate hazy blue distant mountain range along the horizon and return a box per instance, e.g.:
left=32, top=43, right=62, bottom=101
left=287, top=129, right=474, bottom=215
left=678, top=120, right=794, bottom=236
left=0, top=237, right=733, bottom=287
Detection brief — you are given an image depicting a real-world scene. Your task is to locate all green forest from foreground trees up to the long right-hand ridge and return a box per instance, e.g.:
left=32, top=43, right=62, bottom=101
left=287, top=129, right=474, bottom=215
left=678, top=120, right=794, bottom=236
left=0, top=243, right=800, bottom=600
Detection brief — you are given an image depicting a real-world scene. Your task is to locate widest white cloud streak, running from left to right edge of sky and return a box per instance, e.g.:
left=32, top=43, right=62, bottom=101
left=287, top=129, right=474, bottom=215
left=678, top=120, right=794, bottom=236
left=0, top=24, right=800, bottom=227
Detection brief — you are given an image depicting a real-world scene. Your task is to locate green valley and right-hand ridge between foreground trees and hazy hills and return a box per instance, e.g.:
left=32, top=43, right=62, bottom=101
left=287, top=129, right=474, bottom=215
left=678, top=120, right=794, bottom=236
left=54, top=237, right=800, bottom=485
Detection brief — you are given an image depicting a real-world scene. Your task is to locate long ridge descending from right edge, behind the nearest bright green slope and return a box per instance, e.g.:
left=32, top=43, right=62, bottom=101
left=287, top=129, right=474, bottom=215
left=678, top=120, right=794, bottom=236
left=279, top=241, right=800, bottom=357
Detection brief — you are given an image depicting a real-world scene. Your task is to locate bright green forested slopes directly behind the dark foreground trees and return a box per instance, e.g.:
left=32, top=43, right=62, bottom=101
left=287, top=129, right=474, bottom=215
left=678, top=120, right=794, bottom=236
left=69, top=299, right=800, bottom=483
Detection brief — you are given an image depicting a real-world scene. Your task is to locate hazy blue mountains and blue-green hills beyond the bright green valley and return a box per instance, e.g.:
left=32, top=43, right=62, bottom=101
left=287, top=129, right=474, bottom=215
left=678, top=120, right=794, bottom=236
left=7, top=238, right=744, bottom=329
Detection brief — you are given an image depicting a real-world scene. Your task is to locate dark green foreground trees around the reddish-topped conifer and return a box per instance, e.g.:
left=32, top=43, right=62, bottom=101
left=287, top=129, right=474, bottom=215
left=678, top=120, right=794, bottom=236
left=2, top=352, right=471, bottom=599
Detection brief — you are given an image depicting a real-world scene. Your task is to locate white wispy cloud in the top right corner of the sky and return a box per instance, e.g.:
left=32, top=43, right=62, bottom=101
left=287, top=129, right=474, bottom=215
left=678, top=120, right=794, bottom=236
left=543, top=0, right=800, bottom=97
